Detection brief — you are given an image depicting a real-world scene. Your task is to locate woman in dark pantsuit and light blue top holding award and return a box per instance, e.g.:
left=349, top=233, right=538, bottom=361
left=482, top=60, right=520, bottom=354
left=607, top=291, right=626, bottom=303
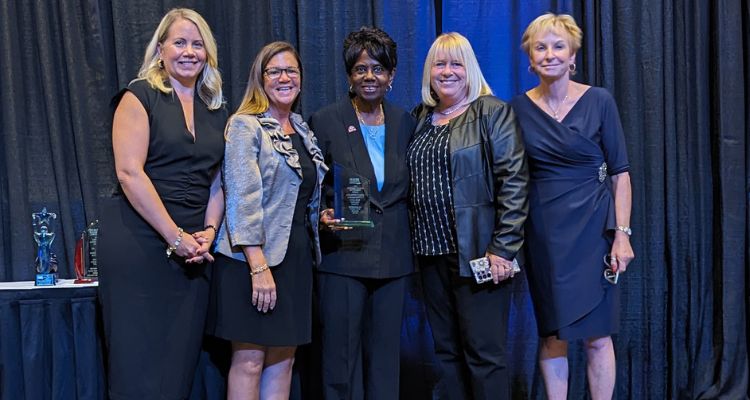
left=310, top=27, right=414, bottom=399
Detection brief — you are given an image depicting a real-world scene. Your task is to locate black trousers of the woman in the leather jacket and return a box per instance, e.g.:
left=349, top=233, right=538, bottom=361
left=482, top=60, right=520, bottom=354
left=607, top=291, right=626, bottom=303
left=419, top=254, right=511, bottom=400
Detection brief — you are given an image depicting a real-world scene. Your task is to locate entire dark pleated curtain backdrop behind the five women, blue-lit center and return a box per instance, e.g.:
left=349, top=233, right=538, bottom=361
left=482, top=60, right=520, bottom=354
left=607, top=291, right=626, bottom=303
left=0, top=0, right=750, bottom=399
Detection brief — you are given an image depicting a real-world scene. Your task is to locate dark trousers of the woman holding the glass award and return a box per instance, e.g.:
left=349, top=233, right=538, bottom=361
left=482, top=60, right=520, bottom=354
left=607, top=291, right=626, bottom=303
left=317, top=272, right=409, bottom=400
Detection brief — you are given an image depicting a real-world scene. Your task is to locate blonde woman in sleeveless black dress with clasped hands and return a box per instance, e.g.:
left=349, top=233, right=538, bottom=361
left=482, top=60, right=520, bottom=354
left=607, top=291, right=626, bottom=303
left=98, top=8, right=227, bottom=399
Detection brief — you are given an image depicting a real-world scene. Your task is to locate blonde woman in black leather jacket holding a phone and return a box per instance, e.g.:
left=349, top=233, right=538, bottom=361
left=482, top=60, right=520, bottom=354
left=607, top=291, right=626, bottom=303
left=407, top=33, right=528, bottom=399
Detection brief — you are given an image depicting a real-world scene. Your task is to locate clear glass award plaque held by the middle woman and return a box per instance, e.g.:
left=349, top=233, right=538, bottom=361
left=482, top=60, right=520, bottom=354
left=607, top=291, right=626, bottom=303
left=333, top=163, right=375, bottom=228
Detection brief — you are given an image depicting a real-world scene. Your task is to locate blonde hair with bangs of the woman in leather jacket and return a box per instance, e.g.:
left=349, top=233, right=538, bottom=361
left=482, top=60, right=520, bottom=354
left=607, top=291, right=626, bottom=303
left=422, top=32, right=492, bottom=107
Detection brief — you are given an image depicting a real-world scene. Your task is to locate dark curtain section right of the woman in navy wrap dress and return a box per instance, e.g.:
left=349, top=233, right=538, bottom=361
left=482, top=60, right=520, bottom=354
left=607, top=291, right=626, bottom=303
left=579, top=0, right=750, bottom=399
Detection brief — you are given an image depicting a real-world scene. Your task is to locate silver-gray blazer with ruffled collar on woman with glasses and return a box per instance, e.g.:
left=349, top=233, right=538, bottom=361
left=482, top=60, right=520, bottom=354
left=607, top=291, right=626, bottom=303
left=215, top=114, right=328, bottom=267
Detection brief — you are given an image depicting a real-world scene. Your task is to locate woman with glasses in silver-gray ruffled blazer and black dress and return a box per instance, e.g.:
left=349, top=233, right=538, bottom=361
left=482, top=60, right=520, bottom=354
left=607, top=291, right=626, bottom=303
left=211, top=42, right=327, bottom=399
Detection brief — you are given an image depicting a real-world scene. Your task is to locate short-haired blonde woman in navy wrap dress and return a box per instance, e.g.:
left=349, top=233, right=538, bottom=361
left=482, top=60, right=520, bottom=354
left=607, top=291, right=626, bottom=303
left=511, top=14, right=634, bottom=399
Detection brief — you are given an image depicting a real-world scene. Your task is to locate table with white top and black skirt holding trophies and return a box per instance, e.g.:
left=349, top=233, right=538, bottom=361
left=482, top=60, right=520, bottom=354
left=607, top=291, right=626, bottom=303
left=0, top=280, right=105, bottom=400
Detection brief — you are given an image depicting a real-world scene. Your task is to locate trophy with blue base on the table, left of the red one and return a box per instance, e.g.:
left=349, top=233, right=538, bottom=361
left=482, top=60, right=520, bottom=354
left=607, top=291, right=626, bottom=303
left=31, top=207, right=57, bottom=286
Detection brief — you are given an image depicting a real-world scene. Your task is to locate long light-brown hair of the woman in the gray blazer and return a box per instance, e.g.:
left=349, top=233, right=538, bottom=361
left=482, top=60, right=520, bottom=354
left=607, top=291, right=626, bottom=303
left=235, top=42, right=302, bottom=115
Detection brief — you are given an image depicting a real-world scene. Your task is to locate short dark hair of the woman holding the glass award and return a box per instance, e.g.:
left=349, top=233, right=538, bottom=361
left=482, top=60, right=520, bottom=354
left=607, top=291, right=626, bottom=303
left=344, top=26, right=398, bottom=74
